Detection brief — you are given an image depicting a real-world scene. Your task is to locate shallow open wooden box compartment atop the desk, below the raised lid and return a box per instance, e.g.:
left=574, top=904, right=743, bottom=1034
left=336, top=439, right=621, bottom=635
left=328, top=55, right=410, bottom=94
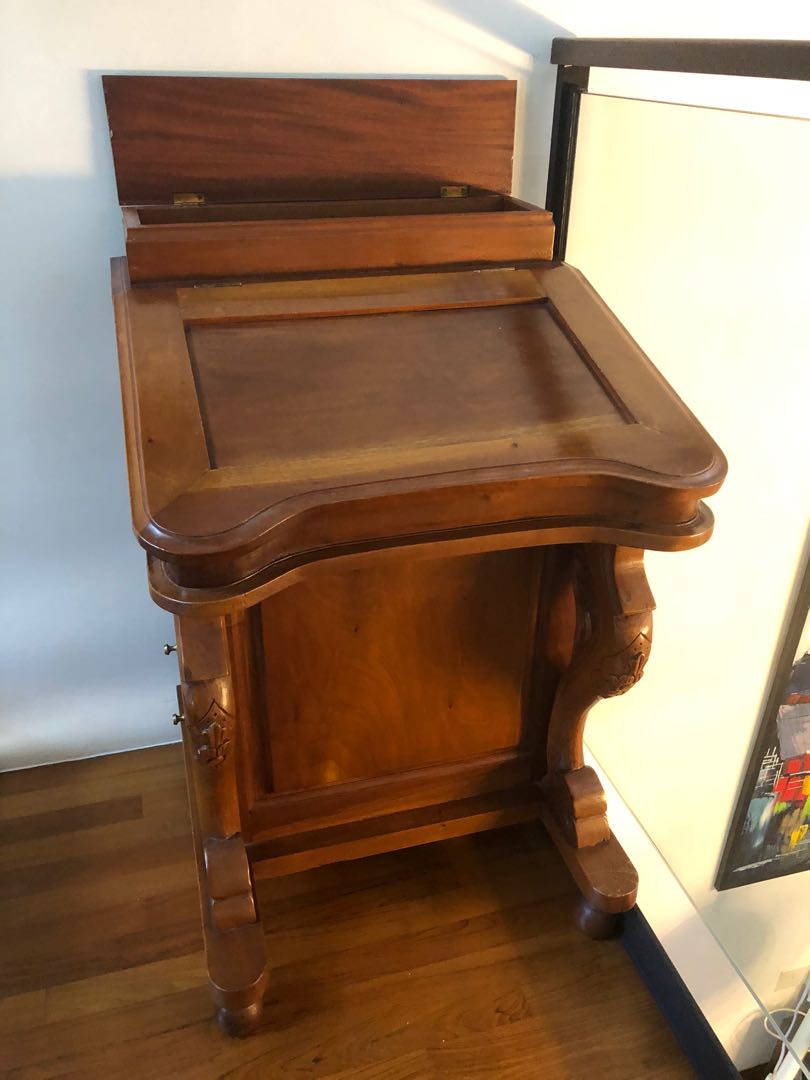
left=124, top=192, right=554, bottom=283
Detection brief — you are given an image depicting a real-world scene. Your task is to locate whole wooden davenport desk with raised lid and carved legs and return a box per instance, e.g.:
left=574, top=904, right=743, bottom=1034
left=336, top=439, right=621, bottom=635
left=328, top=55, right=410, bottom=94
left=105, top=77, right=726, bottom=1034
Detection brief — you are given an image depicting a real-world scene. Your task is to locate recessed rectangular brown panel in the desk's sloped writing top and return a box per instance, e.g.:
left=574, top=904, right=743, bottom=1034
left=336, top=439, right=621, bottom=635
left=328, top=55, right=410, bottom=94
left=187, top=301, right=624, bottom=476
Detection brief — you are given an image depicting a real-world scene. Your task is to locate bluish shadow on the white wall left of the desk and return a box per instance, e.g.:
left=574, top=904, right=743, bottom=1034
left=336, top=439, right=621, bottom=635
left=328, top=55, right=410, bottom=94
left=0, top=174, right=176, bottom=770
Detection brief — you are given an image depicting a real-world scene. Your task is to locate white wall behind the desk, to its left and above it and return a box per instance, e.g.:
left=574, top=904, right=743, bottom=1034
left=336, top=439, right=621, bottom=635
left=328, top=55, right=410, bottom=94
left=0, top=0, right=562, bottom=769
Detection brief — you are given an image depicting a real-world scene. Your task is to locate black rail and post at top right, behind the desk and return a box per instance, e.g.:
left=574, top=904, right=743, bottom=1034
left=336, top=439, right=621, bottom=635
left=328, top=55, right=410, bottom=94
left=545, top=38, right=810, bottom=259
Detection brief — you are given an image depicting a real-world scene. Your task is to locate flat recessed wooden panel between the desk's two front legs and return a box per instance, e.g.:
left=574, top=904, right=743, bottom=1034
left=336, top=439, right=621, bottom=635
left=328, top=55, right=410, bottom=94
left=261, top=550, right=541, bottom=792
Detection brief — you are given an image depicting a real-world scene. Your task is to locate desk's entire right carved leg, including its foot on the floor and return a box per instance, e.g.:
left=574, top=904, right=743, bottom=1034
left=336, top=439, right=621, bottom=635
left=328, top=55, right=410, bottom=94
left=540, top=544, right=654, bottom=937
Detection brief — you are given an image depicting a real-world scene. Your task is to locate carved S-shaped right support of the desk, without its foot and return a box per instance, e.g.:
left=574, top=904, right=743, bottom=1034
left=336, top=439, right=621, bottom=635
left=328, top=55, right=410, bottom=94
left=541, top=544, right=654, bottom=848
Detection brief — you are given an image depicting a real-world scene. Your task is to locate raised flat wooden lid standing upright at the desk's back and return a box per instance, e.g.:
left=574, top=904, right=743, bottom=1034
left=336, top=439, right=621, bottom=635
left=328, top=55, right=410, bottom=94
left=104, top=76, right=516, bottom=206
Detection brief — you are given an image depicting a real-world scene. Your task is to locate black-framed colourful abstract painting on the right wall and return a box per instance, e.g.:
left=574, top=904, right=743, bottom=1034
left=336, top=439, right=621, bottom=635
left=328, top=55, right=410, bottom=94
left=715, top=559, right=810, bottom=889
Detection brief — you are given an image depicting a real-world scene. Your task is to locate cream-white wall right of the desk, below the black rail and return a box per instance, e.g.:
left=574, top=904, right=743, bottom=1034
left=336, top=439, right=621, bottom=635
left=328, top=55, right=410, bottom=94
left=567, top=90, right=810, bottom=1064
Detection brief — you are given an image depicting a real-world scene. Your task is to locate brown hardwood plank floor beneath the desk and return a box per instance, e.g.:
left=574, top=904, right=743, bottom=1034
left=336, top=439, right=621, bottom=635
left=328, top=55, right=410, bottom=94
left=0, top=746, right=693, bottom=1080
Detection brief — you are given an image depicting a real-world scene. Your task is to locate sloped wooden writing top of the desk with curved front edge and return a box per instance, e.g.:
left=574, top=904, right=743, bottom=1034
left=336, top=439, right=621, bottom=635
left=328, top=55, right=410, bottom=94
left=109, top=264, right=726, bottom=610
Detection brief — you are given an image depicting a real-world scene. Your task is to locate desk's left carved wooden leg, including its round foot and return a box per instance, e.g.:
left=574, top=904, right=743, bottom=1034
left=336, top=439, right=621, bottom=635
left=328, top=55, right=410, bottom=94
left=176, top=617, right=267, bottom=1037
